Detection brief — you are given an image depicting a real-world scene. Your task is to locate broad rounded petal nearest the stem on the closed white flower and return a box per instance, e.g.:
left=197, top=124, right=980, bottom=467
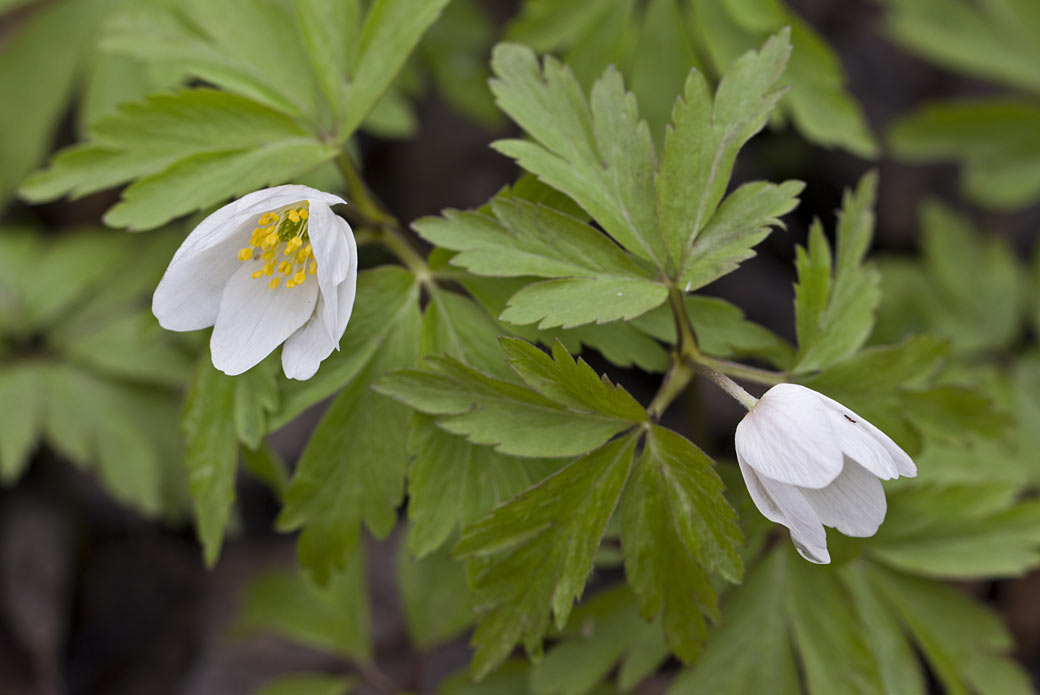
left=734, top=384, right=843, bottom=488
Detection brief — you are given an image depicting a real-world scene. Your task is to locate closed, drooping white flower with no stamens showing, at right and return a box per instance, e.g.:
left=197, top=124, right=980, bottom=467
left=735, top=384, right=917, bottom=563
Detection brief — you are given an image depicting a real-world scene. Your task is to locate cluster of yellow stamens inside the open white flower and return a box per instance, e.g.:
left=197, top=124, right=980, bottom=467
left=238, top=201, right=318, bottom=289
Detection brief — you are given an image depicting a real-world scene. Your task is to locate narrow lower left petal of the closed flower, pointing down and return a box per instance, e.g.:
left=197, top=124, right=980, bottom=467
left=736, top=455, right=831, bottom=564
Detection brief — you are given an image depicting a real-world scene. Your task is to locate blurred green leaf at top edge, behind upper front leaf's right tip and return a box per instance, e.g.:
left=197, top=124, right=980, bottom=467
left=693, top=0, right=878, bottom=157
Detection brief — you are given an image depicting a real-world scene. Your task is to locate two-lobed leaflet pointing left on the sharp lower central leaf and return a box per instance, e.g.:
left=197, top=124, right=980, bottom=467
left=375, top=339, right=647, bottom=458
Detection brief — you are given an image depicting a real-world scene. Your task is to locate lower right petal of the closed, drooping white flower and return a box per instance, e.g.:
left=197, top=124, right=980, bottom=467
left=802, top=460, right=888, bottom=538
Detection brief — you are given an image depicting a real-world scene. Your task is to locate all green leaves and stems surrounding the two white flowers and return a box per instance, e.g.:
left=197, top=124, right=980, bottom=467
left=0, top=0, right=1040, bottom=695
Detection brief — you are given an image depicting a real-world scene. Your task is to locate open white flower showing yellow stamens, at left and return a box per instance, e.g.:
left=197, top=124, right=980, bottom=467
left=152, top=185, right=358, bottom=379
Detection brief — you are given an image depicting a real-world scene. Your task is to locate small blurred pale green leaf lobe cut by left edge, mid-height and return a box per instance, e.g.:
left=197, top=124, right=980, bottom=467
left=0, top=363, right=46, bottom=484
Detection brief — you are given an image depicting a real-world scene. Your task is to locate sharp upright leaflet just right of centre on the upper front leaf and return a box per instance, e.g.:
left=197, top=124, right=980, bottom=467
left=656, top=31, right=790, bottom=273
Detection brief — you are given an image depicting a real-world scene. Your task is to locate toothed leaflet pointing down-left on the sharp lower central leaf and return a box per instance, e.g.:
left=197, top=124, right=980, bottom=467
left=454, top=437, right=635, bottom=678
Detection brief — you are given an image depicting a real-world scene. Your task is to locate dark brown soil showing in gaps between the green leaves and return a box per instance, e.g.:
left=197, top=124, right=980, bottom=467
left=0, top=0, right=1040, bottom=695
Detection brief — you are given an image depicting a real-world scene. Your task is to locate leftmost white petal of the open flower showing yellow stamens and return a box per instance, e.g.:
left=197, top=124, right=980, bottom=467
left=152, top=225, right=244, bottom=331
